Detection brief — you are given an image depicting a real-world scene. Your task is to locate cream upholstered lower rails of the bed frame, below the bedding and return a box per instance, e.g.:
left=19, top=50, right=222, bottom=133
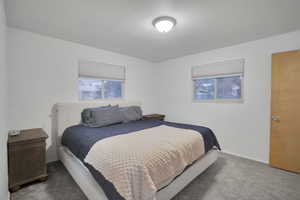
left=58, top=146, right=218, bottom=200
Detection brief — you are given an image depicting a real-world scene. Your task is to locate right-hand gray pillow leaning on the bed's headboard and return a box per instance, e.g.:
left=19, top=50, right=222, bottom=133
left=120, top=106, right=143, bottom=123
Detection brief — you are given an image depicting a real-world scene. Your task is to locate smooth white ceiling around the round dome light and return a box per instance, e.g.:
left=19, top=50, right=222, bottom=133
left=5, top=0, right=300, bottom=62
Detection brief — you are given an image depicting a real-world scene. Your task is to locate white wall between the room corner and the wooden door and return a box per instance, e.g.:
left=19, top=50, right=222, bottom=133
left=155, top=31, right=300, bottom=162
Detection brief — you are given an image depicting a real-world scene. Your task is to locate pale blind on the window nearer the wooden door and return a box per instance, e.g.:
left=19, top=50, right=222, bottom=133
left=192, top=59, right=245, bottom=79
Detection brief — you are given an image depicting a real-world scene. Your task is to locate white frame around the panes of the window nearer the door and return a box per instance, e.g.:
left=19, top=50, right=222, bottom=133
left=191, top=73, right=244, bottom=103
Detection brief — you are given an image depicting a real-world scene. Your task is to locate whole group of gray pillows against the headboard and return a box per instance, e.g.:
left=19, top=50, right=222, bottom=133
left=81, top=105, right=143, bottom=127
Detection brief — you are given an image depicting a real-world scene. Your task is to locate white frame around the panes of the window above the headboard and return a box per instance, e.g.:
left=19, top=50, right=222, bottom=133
left=77, top=76, right=125, bottom=101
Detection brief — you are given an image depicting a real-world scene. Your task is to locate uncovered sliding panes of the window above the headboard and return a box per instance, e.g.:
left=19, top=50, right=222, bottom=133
left=79, top=77, right=124, bottom=100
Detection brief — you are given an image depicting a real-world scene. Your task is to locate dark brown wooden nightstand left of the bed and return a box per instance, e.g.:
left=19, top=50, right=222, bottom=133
left=7, top=129, right=48, bottom=192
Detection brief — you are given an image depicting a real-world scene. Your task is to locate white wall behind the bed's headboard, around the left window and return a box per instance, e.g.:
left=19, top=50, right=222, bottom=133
left=8, top=28, right=156, bottom=161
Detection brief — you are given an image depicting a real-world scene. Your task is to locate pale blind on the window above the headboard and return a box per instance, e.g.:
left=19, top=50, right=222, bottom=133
left=79, top=61, right=125, bottom=80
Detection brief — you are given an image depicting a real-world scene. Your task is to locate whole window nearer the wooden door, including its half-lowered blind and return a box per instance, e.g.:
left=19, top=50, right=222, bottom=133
left=191, top=59, right=245, bottom=102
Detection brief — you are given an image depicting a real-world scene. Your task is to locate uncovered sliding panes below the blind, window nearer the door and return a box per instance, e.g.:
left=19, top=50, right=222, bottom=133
left=193, top=75, right=242, bottom=100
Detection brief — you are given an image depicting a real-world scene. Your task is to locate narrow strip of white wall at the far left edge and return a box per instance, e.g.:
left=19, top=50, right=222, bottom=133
left=0, top=0, right=8, bottom=200
